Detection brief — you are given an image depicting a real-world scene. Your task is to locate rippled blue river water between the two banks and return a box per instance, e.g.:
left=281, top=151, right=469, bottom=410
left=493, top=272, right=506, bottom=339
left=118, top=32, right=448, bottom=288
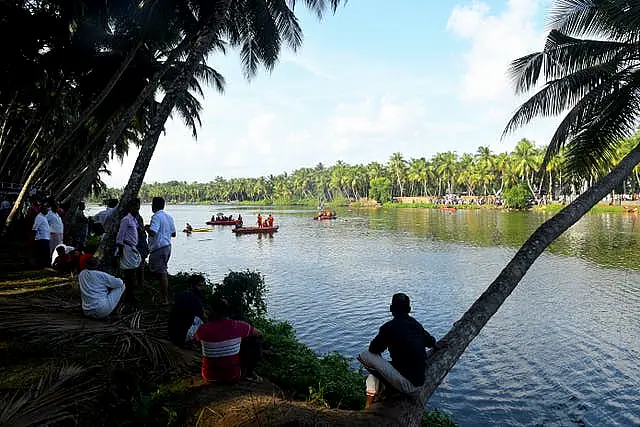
left=92, top=206, right=640, bottom=426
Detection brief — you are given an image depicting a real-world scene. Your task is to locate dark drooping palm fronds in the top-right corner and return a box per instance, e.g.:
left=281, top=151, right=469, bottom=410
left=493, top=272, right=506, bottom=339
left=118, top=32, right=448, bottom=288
left=504, top=0, right=640, bottom=174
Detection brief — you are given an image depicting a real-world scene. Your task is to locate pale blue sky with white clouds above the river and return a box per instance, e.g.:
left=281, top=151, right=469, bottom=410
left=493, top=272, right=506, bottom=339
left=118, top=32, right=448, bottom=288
left=103, top=0, right=558, bottom=187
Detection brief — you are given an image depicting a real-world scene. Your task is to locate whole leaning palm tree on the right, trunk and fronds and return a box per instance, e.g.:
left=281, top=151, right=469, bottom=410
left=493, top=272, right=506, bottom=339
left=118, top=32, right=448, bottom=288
left=410, top=0, right=640, bottom=425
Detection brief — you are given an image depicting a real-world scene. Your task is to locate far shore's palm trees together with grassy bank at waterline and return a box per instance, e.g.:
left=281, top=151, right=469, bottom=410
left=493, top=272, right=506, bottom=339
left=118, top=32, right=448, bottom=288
left=92, top=135, right=640, bottom=212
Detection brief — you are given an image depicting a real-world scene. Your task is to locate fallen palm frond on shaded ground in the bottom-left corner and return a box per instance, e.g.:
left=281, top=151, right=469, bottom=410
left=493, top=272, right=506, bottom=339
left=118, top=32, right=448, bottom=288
left=0, top=365, right=99, bottom=427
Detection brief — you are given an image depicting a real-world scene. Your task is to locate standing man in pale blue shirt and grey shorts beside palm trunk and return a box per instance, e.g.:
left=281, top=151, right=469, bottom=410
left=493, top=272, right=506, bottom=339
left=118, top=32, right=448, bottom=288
left=146, top=197, right=176, bottom=304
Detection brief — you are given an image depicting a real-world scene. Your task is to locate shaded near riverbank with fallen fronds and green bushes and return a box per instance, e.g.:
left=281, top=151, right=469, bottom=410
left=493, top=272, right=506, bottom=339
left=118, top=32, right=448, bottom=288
left=0, top=244, right=453, bottom=426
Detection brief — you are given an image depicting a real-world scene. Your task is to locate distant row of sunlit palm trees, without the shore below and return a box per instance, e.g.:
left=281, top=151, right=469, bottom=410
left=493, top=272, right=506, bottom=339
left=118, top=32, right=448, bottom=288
left=100, top=136, right=640, bottom=203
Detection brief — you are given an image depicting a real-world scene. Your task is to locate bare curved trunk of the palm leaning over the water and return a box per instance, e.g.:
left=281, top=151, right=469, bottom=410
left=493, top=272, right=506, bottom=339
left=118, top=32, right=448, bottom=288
left=364, top=145, right=640, bottom=426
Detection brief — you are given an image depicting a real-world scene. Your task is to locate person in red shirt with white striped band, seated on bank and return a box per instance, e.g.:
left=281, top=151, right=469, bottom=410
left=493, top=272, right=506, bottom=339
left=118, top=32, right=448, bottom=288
left=196, top=299, right=262, bottom=383
